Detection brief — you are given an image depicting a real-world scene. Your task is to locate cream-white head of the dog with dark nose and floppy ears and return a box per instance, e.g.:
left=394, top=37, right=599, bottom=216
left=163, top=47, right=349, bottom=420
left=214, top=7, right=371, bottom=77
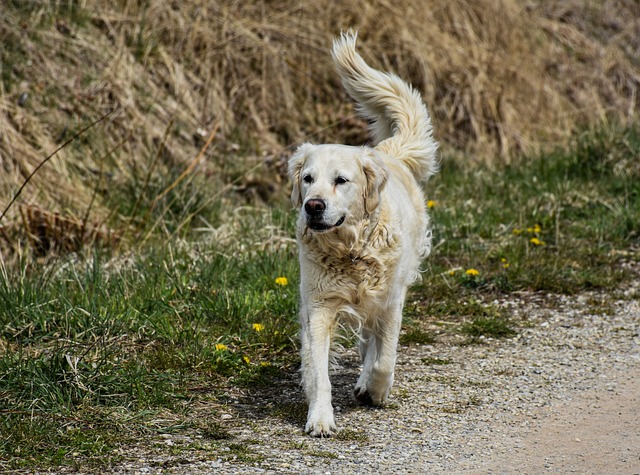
left=289, top=144, right=388, bottom=232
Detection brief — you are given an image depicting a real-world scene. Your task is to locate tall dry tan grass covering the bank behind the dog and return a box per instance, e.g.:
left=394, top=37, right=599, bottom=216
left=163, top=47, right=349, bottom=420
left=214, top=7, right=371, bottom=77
left=0, top=0, right=640, bottom=253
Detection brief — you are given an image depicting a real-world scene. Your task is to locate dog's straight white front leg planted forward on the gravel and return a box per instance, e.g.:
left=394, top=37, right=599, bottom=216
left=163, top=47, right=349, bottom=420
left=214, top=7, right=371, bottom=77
left=300, top=308, right=336, bottom=437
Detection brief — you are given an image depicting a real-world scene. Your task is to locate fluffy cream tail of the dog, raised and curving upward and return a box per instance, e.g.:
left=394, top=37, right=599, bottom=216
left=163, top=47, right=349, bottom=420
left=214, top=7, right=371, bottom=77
left=333, top=32, right=438, bottom=180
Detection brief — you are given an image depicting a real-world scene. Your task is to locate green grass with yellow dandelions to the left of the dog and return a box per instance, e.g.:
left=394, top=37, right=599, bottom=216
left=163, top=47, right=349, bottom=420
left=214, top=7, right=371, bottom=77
left=0, top=240, right=297, bottom=467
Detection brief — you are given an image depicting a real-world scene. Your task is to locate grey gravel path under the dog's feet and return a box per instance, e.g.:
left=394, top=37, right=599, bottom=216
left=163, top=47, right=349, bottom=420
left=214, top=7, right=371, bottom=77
left=66, top=278, right=640, bottom=474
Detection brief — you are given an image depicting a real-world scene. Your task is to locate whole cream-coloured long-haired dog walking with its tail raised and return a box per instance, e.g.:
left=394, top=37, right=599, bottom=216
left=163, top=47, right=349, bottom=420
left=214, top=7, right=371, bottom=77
left=288, top=32, right=438, bottom=437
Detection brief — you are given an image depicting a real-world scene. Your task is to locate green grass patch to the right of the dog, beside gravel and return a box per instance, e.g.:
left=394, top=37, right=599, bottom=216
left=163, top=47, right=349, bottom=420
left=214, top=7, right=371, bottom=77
left=415, top=124, right=640, bottom=317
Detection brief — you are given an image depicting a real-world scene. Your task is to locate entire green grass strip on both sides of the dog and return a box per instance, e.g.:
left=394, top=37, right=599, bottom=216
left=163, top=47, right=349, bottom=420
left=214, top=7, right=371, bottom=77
left=0, top=124, right=640, bottom=470
